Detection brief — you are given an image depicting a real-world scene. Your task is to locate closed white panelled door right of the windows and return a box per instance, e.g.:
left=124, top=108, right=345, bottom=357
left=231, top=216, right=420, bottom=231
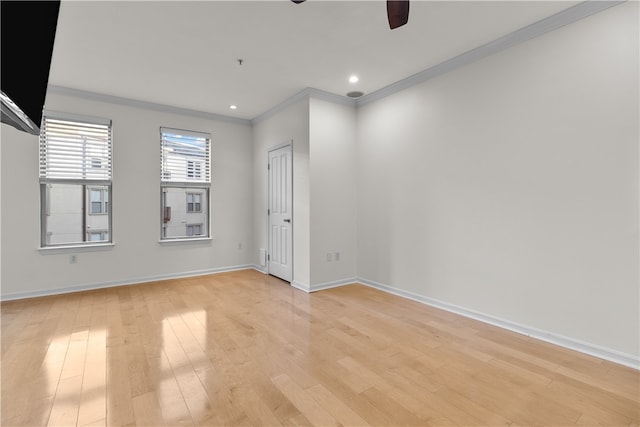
left=267, top=144, right=293, bottom=282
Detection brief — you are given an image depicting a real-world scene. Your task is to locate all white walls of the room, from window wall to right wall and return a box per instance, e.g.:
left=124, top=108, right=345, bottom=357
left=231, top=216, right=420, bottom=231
left=0, top=2, right=640, bottom=366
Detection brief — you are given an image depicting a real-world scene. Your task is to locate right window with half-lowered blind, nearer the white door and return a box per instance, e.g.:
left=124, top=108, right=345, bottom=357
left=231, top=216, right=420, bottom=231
left=160, top=128, right=211, bottom=240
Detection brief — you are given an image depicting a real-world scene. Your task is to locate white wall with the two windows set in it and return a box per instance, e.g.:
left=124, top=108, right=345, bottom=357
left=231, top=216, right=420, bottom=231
left=1, top=93, right=253, bottom=299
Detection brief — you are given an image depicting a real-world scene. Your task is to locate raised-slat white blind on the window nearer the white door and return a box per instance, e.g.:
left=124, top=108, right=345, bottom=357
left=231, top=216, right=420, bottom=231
left=160, top=128, right=211, bottom=184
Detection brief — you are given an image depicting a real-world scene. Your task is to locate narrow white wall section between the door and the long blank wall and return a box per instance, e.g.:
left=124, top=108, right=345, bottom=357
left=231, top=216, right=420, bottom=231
left=309, top=98, right=357, bottom=288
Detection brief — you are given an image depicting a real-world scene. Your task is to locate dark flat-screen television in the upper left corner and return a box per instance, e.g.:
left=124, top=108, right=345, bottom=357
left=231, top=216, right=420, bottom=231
left=0, top=0, right=60, bottom=135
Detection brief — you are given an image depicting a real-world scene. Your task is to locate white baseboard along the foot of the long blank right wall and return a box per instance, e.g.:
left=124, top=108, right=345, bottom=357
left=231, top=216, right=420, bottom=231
left=357, top=277, right=640, bottom=370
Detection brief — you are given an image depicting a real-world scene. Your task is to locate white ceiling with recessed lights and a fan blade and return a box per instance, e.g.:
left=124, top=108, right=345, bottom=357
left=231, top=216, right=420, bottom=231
left=49, top=0, right=579, bottom=119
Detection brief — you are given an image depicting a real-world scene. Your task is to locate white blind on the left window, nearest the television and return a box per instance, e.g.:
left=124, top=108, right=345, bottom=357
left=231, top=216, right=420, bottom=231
left=40, top=115, right=112, bottom=181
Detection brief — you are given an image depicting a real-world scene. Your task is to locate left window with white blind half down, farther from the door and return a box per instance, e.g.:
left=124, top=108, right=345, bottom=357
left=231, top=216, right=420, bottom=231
left=39, top=112, right=112, bottom=247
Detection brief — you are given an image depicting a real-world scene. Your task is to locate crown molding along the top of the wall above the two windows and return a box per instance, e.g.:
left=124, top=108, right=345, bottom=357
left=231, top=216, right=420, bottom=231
left=47, top=85, right=251, bottom=125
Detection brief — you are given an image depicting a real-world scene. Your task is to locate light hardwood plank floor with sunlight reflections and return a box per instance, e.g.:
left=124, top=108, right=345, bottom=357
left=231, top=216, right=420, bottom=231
left=1, top=270, right=640, bottom=426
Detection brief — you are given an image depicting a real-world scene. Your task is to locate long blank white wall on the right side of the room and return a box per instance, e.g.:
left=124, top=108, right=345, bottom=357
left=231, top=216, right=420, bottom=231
left=357, top=2, right=640, bottom=359
